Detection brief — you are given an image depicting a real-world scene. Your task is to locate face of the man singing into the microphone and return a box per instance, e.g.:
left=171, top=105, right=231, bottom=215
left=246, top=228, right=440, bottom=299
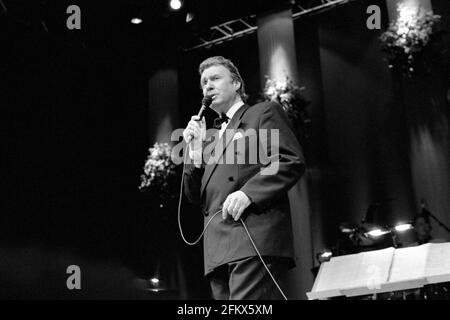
left=200, top=65, right=240, bottom=112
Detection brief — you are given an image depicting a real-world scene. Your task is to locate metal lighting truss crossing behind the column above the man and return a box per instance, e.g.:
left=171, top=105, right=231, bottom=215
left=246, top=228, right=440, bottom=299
left=185, top=0, right=357, bottom=51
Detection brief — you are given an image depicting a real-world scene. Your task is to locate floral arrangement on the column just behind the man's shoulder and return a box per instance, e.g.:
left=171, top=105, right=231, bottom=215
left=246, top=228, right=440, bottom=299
left=263, top=76, right=310, bottom=126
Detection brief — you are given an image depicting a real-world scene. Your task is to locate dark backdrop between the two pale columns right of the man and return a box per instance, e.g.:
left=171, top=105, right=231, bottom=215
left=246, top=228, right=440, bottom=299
left=316, top=1, right=413, bottom=250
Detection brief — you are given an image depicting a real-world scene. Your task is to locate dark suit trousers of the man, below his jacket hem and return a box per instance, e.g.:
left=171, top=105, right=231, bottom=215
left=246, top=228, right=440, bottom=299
left=207, top=256, right=289, bottom=300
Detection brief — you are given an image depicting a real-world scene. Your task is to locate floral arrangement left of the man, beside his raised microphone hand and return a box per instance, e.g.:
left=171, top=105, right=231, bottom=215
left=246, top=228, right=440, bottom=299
left=139, top=142, right=179, bottom=206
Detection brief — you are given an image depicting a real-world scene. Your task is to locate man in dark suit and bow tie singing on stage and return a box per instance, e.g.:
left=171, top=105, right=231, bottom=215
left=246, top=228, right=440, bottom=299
left=183, top=56, right=305, bottom=300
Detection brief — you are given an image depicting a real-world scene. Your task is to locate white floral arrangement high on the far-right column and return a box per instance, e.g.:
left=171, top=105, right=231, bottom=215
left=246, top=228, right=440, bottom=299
left=380, top=3, right=444, bottom=77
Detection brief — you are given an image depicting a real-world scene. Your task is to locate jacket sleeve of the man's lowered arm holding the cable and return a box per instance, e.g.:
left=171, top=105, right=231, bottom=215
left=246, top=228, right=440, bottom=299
left=241, top=103, right=305, bottom=209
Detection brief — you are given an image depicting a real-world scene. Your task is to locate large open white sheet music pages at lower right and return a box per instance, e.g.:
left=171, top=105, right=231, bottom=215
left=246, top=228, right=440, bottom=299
left=307, top=242, right=450, bottom=299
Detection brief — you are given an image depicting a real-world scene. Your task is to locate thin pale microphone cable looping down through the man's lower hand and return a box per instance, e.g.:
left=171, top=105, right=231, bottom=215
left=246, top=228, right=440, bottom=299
left=177, top=143, right=288, bottom=300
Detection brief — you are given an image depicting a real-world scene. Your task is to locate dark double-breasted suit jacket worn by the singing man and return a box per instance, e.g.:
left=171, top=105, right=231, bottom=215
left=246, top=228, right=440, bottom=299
left=184, top=102, right=305, bottom=274
